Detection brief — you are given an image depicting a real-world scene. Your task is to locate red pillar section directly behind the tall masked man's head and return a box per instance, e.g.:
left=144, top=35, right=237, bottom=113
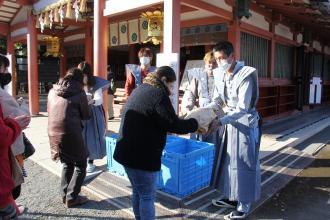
left=228, top=18, right=241, bottom=60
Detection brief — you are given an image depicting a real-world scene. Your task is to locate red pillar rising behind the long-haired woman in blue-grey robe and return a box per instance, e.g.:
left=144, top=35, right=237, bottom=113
left=93, top=0, right=108, bottom=120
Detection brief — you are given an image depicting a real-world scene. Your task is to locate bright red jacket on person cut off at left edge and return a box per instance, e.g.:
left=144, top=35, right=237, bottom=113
left=0, top=105, right=21, bottom=208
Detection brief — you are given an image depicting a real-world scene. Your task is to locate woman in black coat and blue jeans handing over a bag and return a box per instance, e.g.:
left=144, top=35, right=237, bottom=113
left=114, top=66, right=198, bottom=219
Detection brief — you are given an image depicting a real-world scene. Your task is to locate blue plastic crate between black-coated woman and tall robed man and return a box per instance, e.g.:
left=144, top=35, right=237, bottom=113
left=157, top=138, right=214, bottom=198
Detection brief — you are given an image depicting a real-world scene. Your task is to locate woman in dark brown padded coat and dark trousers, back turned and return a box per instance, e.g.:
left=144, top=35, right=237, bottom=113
left=47, top=68, right=91, bottom=208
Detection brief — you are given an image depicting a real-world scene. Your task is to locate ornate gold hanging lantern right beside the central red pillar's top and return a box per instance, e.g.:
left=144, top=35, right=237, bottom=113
left=141, top=10, right=164, bottom=45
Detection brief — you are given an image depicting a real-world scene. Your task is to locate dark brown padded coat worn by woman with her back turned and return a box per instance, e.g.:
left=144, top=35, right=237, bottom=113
left=47, top=80, right=91, bottom=162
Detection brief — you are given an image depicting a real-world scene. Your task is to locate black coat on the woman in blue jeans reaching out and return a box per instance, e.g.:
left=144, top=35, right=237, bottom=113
left=114, top=74, right=198, bottom=171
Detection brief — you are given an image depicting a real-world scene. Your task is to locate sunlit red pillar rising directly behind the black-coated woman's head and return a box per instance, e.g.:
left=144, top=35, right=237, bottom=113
left=161, top=0, right=181, bottom=113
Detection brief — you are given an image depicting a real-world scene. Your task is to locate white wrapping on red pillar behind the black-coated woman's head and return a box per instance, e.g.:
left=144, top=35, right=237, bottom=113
left=156, top=53, right=180, bottom=114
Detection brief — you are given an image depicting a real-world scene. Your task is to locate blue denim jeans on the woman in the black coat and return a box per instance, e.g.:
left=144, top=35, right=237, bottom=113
left=125, top=167, right=158, bottom=220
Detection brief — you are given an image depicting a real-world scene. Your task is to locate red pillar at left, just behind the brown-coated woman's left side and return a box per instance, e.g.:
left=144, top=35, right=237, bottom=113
left=27, top=12, right=39, bottom=115
